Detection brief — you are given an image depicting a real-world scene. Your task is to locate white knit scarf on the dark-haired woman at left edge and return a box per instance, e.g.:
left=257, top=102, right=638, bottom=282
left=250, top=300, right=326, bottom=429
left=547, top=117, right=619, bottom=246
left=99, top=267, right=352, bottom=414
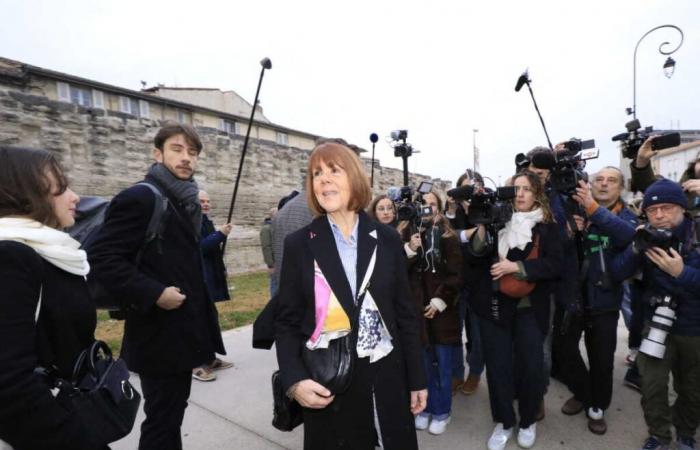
left=0, top=217, right=90, bottom=276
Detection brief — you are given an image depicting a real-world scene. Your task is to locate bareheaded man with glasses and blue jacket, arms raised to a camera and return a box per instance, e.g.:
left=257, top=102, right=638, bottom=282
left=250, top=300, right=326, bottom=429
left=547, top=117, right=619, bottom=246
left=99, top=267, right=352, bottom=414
left=555, top=167, right=637, bottom=434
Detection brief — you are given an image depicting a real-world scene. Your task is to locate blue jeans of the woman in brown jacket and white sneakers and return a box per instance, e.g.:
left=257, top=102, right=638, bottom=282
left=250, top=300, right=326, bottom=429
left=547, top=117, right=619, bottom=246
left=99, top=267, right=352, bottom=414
left=421, top=344, right=457, bottom=420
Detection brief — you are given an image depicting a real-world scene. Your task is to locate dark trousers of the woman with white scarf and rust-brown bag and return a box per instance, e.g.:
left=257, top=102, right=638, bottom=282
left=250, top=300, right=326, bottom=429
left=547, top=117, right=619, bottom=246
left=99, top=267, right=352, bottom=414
left=480, top=308, right=545, bottom=428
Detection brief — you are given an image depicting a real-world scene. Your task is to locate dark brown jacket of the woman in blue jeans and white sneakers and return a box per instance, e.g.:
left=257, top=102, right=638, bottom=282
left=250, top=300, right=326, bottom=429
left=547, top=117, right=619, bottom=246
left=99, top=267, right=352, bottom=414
left=402, top=227, right=463, bottom=345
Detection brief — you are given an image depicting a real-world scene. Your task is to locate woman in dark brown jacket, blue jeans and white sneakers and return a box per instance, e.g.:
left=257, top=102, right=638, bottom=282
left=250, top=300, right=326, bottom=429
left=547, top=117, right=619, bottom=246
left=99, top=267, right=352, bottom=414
left=399, top=192, right=462, bottom=435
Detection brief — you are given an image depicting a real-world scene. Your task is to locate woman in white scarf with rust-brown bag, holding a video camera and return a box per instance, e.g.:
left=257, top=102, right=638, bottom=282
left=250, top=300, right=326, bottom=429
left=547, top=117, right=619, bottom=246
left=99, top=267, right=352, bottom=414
left=471, top=170, right=562, bottom=450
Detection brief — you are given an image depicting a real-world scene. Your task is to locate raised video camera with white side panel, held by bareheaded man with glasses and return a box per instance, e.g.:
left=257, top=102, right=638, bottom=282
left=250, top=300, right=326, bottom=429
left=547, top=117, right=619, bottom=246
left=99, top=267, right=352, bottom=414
left=549, top=138, right=599, bottom=196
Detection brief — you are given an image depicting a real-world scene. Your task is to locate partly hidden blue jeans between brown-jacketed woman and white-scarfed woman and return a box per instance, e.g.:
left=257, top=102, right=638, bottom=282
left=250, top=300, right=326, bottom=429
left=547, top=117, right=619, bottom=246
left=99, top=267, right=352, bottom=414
left=452, top=289, right=484, bottom=380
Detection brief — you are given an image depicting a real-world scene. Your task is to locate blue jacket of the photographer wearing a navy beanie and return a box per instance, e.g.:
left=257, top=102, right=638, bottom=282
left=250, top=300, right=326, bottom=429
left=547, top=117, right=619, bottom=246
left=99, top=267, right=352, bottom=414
left=611, top=217, right=700, bottom=336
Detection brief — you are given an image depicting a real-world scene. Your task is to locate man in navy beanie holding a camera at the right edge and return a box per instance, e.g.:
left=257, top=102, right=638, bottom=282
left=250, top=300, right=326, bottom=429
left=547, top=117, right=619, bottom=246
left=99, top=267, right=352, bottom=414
left=611, top=180, right=700, bottom=450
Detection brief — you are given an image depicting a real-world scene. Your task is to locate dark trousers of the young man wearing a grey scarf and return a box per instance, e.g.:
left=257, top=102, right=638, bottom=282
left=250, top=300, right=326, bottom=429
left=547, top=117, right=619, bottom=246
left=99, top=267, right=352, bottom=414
left=139, top=372, right=192, bottom=450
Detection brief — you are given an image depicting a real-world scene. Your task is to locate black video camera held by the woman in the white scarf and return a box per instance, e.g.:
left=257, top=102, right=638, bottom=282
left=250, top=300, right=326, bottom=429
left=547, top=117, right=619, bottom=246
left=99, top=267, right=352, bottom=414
left=447, top=186, right=515, bottom=226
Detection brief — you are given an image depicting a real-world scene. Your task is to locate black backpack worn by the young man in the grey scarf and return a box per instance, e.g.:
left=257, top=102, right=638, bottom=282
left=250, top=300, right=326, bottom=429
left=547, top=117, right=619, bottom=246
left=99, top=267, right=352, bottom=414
left=68, top=182, right=168, bottom=320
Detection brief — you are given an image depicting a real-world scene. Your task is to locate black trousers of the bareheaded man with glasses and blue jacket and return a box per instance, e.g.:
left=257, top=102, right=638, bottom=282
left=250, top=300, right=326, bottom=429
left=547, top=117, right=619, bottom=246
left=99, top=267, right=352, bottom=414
left=557, top=311, right=620, bottom=410
